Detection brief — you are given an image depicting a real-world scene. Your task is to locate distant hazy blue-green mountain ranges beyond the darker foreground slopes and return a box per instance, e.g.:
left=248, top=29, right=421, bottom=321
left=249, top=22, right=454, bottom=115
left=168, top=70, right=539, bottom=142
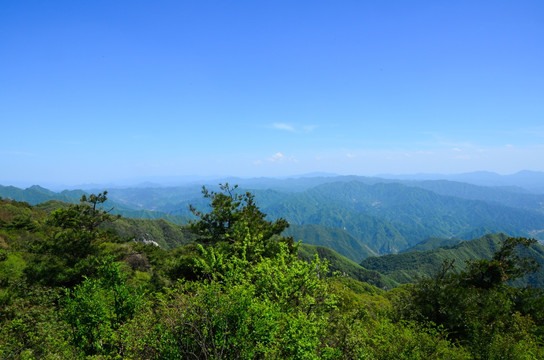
left=4, top=176, right=544, bottom=262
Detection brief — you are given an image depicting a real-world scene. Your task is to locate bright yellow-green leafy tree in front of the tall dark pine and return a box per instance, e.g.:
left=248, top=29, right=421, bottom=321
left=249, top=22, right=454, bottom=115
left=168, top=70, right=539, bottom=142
left=126, top=244, right=334, bottom=359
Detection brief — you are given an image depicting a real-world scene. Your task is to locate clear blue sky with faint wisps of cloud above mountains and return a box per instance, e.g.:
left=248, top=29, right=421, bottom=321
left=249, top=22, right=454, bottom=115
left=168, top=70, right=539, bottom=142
left=0, top=0, right=544, bottom=185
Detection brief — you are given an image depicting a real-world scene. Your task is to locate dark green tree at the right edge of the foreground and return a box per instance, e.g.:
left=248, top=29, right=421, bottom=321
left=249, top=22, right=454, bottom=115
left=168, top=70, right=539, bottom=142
left=396, top=238, right=542, bottom=359
